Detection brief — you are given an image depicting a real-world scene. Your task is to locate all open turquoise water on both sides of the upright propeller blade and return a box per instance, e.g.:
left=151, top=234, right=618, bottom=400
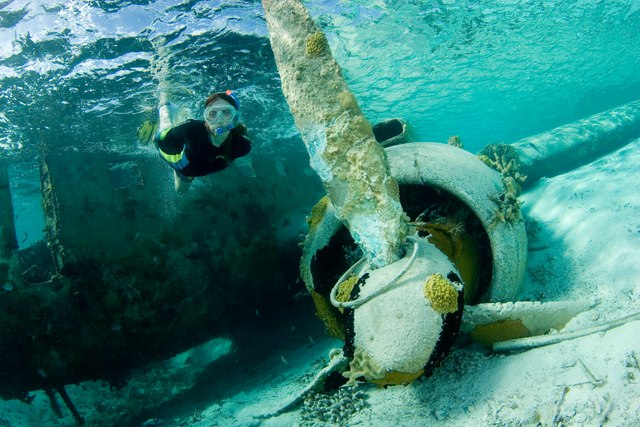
left=0, top=0, right=640, bottom=424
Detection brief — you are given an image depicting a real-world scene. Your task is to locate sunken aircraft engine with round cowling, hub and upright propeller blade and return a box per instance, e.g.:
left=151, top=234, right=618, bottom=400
left=263, top=0, right=526, bottom=390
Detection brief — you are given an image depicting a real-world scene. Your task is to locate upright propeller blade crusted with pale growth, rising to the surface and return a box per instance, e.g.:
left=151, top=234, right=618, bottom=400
left=262, top=0, right=407, bottom=268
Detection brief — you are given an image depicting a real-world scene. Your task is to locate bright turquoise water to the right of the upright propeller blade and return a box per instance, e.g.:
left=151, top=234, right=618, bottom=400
left=318, top=1, right=640, bottom=145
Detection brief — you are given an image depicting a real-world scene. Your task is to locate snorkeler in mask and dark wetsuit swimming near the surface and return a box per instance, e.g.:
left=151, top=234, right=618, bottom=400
left=156, top=90, right=254, bottom=193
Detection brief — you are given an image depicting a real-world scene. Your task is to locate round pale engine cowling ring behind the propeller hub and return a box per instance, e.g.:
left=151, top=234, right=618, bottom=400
left=301, top=143, right=527, bottom=302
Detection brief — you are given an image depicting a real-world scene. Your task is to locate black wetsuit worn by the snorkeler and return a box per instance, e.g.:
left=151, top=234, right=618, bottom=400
left=157, top=120, right=251, bottom=178
